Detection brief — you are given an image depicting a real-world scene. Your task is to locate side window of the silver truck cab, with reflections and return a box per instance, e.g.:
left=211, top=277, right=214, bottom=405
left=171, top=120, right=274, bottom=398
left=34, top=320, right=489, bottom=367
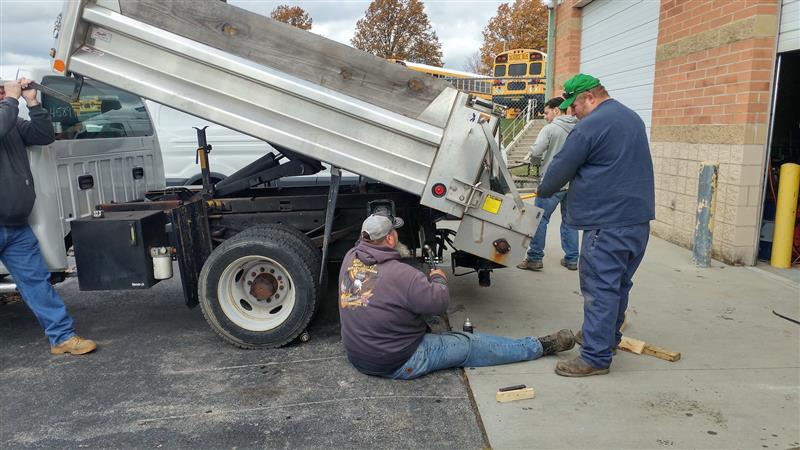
left=42, top=76, right=153, bottom=140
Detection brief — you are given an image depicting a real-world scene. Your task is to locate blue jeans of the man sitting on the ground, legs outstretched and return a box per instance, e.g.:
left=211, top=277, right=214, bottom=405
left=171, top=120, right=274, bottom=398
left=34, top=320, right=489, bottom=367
left=387, top=331, right=542, bottom=380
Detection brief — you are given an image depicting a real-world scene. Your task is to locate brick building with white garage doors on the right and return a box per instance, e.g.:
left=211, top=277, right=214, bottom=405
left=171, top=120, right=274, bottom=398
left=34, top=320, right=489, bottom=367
left=550, top=0, right=800, bottom=264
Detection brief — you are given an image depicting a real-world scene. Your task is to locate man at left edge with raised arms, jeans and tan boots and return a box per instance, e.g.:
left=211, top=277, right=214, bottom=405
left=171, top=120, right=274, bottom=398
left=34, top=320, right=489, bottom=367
left=0, top=78, right=97, bottom=355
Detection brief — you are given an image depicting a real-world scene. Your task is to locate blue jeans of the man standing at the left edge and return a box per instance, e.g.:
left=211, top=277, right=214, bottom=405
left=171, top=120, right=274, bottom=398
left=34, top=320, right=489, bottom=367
left=0, top=225, right=75, bottom=345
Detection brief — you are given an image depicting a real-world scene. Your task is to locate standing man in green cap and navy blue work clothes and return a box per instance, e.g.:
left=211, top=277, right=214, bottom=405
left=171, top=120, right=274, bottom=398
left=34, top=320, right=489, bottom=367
left=538, top=74, right=655, bottom=377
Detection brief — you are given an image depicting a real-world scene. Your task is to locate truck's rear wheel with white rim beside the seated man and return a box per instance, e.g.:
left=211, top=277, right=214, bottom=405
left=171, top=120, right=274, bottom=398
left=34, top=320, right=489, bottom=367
left=199, top=229, right=318, bottom=348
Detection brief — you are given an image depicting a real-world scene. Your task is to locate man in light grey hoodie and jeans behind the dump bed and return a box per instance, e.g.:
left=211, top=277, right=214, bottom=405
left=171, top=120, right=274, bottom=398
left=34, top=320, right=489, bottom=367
left=517, top=97, right=578, bottom=271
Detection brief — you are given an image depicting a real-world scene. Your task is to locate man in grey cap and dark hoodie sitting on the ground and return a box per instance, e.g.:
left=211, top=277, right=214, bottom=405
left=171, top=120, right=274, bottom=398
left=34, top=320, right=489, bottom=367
left=339, top=214, right=575, bottom=380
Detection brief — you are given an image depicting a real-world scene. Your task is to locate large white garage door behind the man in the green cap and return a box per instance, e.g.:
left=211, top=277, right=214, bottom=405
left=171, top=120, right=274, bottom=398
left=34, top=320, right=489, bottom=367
left=581, top=0, right=660, bottom=136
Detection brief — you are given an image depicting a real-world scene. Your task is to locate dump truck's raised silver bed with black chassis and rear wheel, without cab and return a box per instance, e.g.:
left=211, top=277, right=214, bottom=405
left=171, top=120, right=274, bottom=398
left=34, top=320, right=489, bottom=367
left=52, top=0, right=541, bottom=348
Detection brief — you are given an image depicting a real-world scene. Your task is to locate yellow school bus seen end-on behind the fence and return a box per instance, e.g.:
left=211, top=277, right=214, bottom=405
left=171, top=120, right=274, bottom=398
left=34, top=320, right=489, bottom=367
left=492, top=48, right=547, bottom=116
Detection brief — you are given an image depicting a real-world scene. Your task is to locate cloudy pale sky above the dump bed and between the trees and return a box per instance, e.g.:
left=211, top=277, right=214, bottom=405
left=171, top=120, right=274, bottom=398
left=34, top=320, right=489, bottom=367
left=0, top=0, right=503, bottom=76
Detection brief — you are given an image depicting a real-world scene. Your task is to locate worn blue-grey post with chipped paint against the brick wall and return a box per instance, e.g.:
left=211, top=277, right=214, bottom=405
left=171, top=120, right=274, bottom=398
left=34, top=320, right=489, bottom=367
left=692, top=163, right=719, bottom=267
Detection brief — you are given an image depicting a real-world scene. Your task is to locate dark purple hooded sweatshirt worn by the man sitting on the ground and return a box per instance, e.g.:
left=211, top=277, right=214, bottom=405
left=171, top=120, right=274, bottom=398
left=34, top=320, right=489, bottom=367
left=339, top=241, right=450, bottom=375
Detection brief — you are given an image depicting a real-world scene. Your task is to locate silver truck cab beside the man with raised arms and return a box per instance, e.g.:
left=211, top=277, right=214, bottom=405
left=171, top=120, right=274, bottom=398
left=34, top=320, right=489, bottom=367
left=0, top=66, right=165, bottom=280
